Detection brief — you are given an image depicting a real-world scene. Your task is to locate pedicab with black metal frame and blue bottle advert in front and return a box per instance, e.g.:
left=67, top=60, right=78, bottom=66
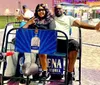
left=1, top=22, right=81, bottom=85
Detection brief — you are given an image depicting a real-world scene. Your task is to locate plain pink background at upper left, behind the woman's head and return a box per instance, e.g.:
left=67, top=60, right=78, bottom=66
left=0, top=0, right=53, bottom=15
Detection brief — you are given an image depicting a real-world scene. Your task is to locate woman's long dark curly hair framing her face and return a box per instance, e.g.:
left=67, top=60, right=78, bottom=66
left=34, top=4, right=54, bottom=24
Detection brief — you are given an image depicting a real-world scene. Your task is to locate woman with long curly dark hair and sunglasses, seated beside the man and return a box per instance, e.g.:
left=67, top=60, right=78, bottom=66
left=24, top=4, right=55, bottom=78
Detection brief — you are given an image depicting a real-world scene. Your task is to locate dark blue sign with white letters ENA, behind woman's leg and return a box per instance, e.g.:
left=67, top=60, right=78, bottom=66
left=36, top=55, right=64, bottom=74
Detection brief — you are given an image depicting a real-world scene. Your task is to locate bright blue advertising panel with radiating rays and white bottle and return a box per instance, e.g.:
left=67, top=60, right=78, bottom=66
left=15, top=28, right=57, bottom=54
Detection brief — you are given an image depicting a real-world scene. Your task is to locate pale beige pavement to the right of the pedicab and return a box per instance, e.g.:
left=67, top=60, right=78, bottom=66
left=0, top=22, right=100, bottom=85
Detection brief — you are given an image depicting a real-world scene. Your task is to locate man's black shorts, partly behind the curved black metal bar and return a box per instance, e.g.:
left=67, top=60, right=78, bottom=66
left=57, top=39, right=79, bottom=53
